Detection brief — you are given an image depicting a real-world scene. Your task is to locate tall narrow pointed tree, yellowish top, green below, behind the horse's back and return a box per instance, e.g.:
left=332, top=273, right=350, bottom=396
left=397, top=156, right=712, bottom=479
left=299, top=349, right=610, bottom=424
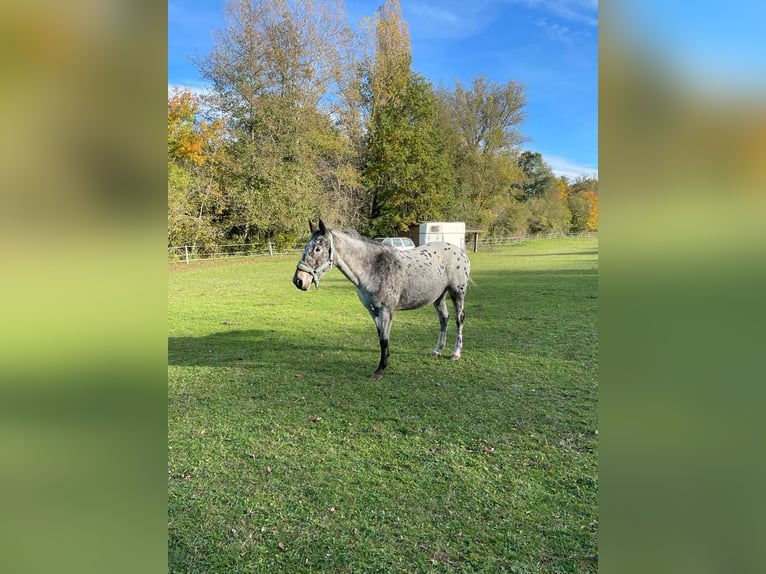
left=362, top=0, right=451, bottom=234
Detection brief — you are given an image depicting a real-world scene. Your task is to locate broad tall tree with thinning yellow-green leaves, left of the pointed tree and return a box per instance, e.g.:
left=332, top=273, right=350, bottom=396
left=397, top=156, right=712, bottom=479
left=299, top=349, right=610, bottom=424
left=198, top=0, right=354, bottom=242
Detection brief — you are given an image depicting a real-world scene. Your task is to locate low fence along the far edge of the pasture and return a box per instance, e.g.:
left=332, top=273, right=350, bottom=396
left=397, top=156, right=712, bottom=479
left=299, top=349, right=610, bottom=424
left=168, top=231, right=598, bottom=263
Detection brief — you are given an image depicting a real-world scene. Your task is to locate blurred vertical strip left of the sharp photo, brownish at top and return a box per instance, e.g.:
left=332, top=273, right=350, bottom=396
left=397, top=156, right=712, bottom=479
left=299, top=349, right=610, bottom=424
left=0, top=0, right=167, bottom=573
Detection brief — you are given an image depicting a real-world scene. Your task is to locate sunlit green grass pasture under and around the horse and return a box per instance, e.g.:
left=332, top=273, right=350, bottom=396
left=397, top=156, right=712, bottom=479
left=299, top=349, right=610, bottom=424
left=168, top=238, right=598, bottom=574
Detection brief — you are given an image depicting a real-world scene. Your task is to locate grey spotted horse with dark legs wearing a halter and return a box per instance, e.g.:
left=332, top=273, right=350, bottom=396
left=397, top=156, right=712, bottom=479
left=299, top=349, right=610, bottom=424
left=293, top=223, right=471, bottom=380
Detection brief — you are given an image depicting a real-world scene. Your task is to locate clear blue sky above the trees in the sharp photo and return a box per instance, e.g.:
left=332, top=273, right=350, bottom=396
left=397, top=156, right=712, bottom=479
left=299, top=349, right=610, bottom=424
left=168, top=0, right=598, bottom=178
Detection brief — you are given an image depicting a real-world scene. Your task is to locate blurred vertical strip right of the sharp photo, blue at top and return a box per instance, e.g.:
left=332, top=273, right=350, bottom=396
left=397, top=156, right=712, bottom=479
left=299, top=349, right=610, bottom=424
left=599, top=1, right=766, bottom=572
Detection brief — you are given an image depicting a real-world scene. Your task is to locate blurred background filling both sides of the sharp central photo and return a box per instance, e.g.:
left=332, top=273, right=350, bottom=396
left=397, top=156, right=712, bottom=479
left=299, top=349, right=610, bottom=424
left=0, top=0, right=766, bottom=573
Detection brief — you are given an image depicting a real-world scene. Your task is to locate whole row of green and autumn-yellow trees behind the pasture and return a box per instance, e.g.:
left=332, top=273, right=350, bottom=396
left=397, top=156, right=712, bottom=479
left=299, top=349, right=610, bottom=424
left=168, top=0, right=598, bottom=253
